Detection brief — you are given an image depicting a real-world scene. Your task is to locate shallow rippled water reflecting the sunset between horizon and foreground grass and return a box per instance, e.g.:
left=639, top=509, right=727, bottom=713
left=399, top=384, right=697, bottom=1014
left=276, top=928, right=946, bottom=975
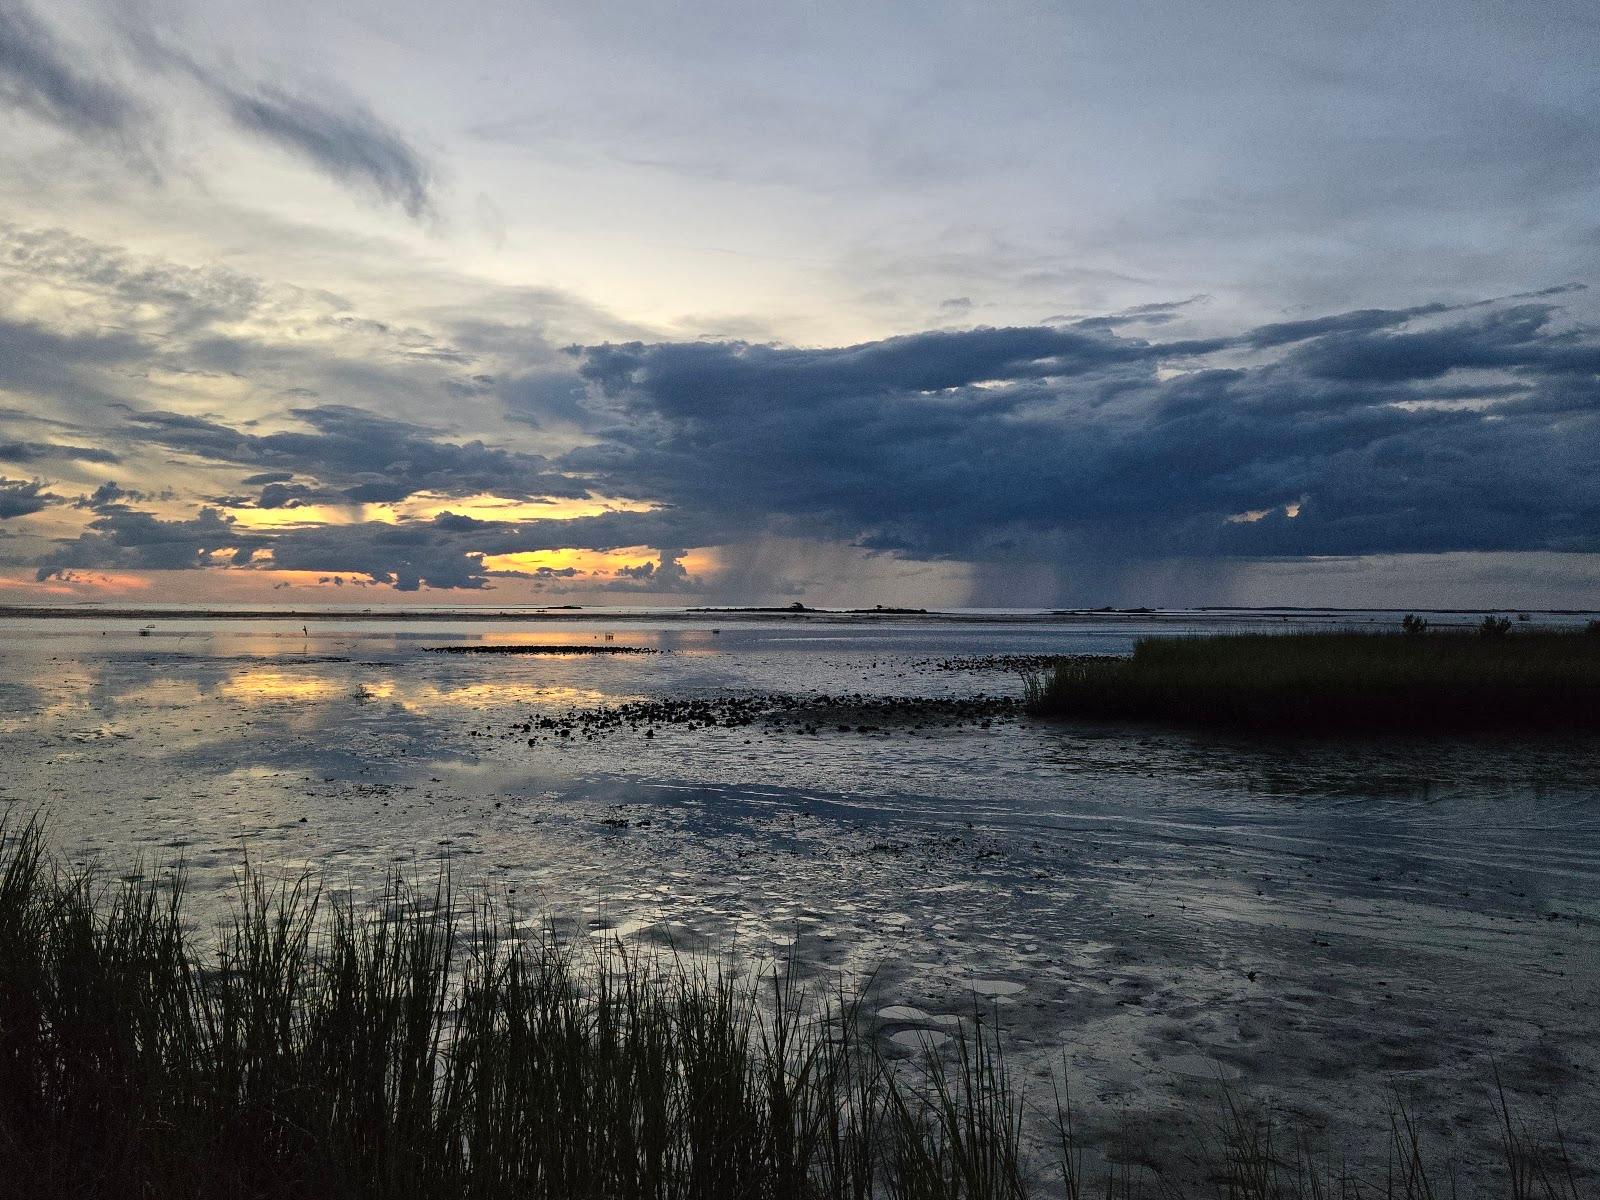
left=0, top=613, right=1600, bottom=1196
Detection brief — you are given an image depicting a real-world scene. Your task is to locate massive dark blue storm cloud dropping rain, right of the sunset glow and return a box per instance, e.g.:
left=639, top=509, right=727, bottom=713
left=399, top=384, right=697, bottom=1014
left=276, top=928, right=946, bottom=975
left=558, top=304, right=1600, bottom=569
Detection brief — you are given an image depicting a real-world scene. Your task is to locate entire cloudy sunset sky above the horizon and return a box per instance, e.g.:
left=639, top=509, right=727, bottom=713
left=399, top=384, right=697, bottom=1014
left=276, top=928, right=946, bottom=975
left=0, top=0, right=1600, bottom=608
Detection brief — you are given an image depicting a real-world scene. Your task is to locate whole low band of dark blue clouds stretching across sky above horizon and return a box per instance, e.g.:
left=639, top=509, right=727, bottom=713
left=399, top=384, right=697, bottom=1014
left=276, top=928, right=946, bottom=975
left=0, top=267, right=1600, bottom=602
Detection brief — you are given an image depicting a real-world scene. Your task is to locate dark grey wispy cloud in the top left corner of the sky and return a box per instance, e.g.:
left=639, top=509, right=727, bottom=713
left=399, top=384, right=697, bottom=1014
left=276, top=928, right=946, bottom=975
left=0, top=0, right=146, bottom=139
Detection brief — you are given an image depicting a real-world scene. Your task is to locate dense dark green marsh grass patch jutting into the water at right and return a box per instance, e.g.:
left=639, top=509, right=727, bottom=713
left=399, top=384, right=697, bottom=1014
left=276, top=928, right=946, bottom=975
left=1027, top=622, right=1600, bottom=731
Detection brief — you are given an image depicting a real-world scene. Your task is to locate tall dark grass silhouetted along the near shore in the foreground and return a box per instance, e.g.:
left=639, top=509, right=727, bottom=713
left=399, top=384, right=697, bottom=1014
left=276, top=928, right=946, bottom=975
left=0, top=824, right=1579, bottom=1200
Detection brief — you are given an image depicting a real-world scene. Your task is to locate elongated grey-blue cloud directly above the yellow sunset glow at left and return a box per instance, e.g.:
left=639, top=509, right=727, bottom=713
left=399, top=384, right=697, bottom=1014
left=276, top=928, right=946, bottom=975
left=126, top=405, right=587, bottom=507
